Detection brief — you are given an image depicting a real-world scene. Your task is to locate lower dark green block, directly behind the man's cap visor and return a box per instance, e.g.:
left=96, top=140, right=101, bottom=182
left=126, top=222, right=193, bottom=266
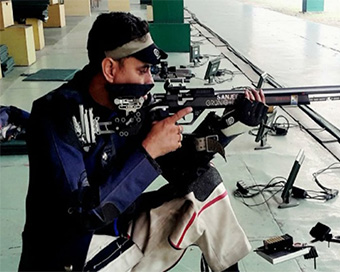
left=150, top=23, right=190, bottom=52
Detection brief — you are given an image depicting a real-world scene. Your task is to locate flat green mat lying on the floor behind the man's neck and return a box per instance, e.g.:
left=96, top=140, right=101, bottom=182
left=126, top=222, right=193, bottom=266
left=23, top=69, right=78, bottom=81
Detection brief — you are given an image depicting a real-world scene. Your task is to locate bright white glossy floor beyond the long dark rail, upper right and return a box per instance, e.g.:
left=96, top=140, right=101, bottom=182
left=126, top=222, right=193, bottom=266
left=185, top=0, right=340, bottom=154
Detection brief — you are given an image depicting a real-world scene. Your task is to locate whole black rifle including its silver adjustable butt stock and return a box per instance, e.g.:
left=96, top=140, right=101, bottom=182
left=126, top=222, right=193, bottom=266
left=74, top=81, right=340, bottom=145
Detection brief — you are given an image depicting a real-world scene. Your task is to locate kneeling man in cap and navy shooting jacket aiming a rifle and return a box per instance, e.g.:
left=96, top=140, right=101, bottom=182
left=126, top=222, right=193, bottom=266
left=19, top=12, right=265, bottom=271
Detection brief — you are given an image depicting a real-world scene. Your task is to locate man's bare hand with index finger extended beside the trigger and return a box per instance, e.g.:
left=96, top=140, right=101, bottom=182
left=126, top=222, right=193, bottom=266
left=142, top=107, right=192, bottom=159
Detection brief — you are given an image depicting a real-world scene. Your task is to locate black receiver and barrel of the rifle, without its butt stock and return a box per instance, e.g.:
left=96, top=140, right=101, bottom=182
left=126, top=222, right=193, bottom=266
left=150, top=81, right=340, bottom=124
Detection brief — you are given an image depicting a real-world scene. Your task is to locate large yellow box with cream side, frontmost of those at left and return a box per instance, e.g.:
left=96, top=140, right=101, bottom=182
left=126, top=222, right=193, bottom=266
left=0, top=24, right=36, bottom=66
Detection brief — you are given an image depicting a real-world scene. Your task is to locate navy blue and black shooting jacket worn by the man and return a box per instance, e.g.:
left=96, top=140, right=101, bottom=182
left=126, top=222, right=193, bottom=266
left=19, top=67, right=161, bottom=271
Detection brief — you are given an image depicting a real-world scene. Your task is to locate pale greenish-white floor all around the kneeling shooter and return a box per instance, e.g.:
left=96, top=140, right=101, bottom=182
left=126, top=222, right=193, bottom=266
left=0, top=0, right=340, bottom=272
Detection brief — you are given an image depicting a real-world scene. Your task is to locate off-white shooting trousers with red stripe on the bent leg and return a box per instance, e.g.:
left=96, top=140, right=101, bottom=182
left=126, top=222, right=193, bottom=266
left=87, top=183, right=251, bottom=272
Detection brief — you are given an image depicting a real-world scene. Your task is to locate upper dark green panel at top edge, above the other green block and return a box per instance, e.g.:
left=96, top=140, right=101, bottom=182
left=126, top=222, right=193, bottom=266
left=152, top=0, right=184, bottom=23
